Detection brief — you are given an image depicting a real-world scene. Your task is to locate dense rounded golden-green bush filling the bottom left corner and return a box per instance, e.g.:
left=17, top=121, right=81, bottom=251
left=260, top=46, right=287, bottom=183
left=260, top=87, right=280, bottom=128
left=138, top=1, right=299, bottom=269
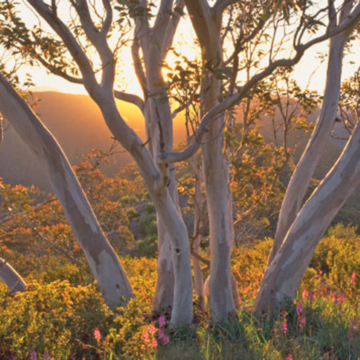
left=0, top=281, right=112, bottom=359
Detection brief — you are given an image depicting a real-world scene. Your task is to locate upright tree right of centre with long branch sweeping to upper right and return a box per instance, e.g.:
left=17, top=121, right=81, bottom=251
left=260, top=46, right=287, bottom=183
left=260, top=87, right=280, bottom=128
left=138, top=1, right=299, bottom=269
left=162, top=0, right=359, bottom=321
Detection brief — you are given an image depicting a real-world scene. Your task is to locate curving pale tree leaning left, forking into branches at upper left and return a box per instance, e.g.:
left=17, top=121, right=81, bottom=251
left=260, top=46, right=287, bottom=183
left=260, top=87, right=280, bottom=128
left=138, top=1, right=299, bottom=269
left=3, top=0, right=192, bottom=324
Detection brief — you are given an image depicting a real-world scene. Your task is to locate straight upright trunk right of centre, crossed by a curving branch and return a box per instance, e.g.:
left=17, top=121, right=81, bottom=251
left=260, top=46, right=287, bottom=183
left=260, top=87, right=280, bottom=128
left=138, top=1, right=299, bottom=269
left=185, top=0, right=237, bottom=322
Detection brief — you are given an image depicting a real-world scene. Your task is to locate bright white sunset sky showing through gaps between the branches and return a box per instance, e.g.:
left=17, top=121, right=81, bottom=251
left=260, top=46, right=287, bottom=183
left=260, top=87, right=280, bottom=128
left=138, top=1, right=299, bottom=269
left=7, top=1, right=359, bottom=96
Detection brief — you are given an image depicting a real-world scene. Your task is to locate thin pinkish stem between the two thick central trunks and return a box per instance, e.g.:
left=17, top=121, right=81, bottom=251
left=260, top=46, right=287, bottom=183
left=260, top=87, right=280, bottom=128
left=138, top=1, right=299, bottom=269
left=190, top=156, right=205, bottom=309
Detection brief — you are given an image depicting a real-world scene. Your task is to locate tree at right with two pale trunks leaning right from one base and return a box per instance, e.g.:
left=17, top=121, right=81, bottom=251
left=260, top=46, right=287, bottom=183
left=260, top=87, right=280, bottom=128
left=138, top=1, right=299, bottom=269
left=255, top=1, right=358, bottom=311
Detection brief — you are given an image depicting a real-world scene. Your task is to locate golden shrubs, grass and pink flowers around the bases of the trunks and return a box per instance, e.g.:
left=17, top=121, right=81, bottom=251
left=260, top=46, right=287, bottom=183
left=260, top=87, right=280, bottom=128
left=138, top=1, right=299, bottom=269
left=0, top=225, right=360, bottom=360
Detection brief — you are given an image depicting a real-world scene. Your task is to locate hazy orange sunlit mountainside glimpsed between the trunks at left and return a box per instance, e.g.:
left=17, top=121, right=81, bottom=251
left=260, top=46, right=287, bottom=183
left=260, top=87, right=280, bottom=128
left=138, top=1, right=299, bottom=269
left=0, top=92, right=185, bottom=191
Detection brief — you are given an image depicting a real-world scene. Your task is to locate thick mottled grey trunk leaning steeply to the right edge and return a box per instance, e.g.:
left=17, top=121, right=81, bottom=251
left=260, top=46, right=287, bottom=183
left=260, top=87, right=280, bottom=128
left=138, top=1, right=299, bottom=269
left=254, top=117, right=360, bottom=312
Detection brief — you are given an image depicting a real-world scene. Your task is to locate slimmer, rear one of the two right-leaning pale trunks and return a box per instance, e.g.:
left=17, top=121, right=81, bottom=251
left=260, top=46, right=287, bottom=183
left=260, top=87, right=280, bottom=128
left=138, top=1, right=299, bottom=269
left=268, top=15, right=352, bottom=265
